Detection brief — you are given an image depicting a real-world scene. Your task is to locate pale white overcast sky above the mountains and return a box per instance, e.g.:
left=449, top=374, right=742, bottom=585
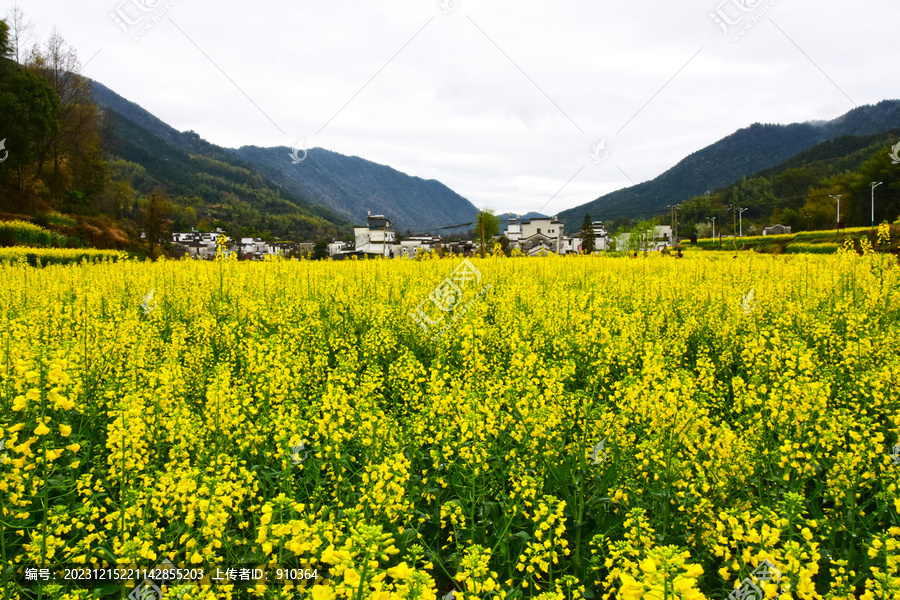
left=8, top=0, right=900, bottom=214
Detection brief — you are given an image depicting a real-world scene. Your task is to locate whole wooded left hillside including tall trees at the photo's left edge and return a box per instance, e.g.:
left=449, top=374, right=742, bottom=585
left=0, top=16, right=351, bottom=256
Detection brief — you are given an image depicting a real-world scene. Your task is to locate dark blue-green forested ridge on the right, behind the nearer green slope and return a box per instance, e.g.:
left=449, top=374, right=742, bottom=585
left=559, top=100, right=900, bottom=231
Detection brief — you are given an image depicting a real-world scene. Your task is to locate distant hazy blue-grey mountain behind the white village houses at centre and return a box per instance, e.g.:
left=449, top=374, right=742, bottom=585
left=237, top=146, right=478, bottom=233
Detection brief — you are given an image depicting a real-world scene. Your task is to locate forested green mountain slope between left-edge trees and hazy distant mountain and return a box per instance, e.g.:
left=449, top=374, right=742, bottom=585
left=91, top=82, right=352, bottom=240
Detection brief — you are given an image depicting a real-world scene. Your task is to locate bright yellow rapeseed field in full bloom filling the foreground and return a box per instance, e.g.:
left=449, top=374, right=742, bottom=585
left=0, top=245, right=900, bottom=600
